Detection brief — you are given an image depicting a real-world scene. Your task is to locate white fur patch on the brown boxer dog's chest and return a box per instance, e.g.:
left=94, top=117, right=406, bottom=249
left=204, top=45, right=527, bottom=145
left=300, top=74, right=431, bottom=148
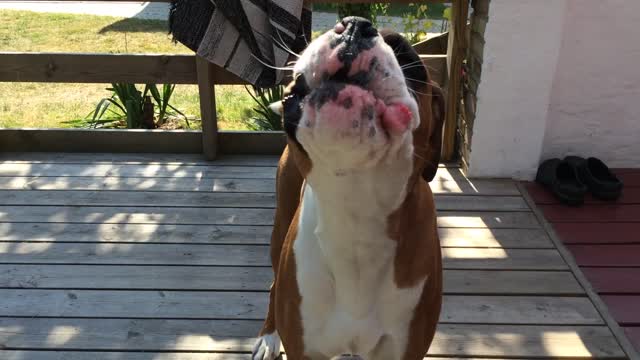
left=294, top=186, right=424, bottom=359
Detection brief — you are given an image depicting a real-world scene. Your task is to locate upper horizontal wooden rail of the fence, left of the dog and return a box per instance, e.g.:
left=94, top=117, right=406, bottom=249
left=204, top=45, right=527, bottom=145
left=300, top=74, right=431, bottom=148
left=0, top=52, right=246, bottom=84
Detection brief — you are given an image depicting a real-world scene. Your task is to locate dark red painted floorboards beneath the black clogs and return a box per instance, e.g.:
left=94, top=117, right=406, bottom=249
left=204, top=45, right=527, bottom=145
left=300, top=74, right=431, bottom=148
left=525, top=169, right=640, bottom=351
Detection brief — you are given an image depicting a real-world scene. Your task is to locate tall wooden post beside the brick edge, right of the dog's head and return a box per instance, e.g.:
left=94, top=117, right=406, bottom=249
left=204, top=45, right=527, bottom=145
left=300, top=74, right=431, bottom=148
left=441, top=0, right=469, bottom=161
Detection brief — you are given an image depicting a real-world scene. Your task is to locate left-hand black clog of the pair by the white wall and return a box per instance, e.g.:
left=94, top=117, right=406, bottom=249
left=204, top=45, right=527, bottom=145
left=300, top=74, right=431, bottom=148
left=536, top=159, right=587, bottom=206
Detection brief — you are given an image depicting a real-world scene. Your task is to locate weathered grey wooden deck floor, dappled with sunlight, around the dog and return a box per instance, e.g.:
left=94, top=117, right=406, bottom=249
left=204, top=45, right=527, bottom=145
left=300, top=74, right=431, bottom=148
left=0, top=154, right=626, bottom=360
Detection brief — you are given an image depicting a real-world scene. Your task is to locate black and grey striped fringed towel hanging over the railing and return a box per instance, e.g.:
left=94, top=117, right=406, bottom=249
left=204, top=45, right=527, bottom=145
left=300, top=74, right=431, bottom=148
left=169, top=0, right=311, bottom=87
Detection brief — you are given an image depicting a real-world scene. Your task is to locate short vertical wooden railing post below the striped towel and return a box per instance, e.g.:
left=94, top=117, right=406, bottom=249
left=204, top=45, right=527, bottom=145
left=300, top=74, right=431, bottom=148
left=196, top=56, right=218, bottom=160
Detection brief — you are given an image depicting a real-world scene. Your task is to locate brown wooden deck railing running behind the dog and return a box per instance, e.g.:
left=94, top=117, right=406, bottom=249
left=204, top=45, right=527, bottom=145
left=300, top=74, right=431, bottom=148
left=0, top=0, right=468, bottom=159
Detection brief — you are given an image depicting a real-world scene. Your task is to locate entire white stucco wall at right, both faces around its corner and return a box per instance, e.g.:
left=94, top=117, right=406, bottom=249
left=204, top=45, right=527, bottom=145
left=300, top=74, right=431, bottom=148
left=469, top=0, right=640, bottom=179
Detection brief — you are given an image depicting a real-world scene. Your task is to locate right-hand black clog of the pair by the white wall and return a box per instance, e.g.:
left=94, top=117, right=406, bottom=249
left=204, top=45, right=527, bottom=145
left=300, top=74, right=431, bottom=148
left=564, top=156, right=623, bottom=200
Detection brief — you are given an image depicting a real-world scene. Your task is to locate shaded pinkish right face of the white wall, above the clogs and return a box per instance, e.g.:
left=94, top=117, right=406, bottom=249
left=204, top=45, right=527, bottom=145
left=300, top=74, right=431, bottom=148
left=542, top=0, right=640, bottom=167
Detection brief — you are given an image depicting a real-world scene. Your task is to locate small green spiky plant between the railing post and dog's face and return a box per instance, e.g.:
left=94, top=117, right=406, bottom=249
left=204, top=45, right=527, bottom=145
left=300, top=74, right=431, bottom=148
left=243, top=85, right=284, bottom=131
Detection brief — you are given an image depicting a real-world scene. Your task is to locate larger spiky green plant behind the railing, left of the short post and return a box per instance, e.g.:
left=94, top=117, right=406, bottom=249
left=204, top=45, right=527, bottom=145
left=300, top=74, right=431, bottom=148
left=87, top=83, right=189, bottom=129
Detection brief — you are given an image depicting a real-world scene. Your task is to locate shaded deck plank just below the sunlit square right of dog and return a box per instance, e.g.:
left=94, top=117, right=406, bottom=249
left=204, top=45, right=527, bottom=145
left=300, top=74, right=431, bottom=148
left=0, top=265, right=584, bottom=296
